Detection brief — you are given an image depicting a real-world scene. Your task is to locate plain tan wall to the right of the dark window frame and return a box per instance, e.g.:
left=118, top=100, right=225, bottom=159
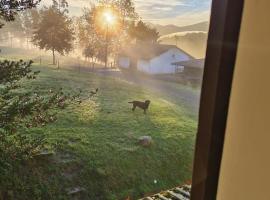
left=217, top=0, right=270, bottom=200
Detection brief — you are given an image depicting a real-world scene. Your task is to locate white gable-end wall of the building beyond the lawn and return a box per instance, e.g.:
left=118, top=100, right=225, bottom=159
left=149, top=48, right=190, bottom=74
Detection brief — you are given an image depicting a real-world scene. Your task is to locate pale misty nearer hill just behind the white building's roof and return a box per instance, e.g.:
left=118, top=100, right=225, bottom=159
left=159, top=31, right=207, bottom=58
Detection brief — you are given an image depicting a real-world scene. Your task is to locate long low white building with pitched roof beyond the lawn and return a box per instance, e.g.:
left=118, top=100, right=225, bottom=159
left=118, top=44, right=193, bottom=74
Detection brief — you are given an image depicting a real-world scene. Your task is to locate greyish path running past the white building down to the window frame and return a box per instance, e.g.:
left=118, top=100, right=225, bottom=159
left=95, top=70, right=200, bottom=117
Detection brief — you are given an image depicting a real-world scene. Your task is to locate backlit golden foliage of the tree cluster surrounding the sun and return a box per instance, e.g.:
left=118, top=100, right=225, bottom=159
left=77, top=0, right=138, bottom=66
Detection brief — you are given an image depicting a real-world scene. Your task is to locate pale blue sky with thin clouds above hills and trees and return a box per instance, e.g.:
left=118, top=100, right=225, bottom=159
left=44, top=0, right=211, bottom=26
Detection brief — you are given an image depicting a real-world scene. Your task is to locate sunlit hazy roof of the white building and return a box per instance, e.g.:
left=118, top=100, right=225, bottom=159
left=119, top=44, right=193, bottom=60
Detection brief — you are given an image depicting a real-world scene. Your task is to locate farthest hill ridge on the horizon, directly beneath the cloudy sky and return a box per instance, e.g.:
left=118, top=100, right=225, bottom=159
left=152, top=21, right=209, bottom=36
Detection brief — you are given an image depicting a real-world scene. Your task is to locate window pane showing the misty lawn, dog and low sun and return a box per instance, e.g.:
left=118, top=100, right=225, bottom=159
left=0, top=0, right=211, bottom=200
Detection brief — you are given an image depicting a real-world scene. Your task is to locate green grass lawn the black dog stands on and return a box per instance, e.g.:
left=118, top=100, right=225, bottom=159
left=18, top=66, right=197, bottom=200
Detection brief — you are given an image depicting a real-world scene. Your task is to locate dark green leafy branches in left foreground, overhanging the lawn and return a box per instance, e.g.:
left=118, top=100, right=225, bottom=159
left=0, top=60, right=81, bottom=198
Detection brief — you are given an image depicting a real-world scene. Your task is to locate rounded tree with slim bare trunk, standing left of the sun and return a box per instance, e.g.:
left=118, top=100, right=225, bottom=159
left=33, top=6, right=74, bottom=65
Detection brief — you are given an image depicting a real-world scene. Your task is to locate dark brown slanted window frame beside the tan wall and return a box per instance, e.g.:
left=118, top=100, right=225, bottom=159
left=191, top=0, right=244, bottom=200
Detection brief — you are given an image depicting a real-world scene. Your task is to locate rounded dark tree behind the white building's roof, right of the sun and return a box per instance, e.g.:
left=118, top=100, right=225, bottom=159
left=129, top=20, right=159, bottom=43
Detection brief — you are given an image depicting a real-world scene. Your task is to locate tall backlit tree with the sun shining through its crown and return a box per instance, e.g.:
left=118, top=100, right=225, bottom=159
left=91, top=0, right=138, bottom=65
